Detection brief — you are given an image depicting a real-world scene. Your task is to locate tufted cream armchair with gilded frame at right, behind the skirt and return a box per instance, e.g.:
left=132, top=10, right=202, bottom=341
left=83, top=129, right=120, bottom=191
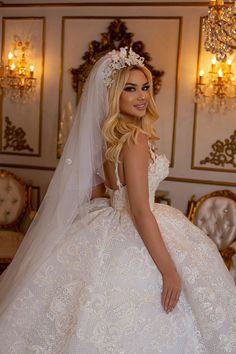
left=187, top=190, right=236, bottom=280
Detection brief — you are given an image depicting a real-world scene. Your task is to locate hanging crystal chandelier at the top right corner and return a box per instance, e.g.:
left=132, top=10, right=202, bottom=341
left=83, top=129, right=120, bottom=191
left=202, top=0, right=236, bottom=62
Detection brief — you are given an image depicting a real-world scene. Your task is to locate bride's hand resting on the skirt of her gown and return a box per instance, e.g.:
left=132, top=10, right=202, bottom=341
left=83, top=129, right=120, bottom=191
left=161, top=269, right=181, bottom=313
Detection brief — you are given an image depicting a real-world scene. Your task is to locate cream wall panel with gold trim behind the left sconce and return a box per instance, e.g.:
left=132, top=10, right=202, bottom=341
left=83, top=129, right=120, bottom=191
left=1, top=17, right=45, bottom=156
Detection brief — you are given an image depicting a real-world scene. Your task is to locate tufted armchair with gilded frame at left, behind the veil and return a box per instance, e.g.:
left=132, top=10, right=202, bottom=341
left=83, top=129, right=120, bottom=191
left=0, top=170, right=35, bottom=273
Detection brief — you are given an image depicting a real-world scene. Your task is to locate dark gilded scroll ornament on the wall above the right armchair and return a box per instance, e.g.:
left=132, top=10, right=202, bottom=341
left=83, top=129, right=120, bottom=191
left=200, top=130, right=236, bottom=167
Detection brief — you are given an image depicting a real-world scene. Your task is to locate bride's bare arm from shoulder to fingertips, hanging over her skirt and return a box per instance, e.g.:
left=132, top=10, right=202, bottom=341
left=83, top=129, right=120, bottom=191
left=122, top=133, right=181, bottom=312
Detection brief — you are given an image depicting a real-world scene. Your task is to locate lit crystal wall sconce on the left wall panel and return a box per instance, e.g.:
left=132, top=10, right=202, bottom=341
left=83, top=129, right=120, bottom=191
left=0, top=36, right=36, bottom=103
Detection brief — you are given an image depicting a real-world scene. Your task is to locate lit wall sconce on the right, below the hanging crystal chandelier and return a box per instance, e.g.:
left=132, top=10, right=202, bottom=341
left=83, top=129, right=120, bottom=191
left=194, top=56, right=236, bottom=113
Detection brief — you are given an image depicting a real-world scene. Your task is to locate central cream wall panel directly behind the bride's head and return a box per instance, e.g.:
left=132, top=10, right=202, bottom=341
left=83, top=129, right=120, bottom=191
left=60, top=17, right=181, bottom=162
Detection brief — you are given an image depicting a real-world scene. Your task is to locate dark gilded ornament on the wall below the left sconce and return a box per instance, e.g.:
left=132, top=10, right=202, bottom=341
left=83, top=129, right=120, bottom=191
left=3, top=117, right=34, bottom=152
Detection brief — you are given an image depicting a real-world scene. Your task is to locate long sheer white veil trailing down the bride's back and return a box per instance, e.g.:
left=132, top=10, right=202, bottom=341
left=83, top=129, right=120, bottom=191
left=0, top=54, right=111, bottom=315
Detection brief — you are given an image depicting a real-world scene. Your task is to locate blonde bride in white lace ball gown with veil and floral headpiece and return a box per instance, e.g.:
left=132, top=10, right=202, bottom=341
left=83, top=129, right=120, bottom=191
left=0, top=48, right=236, bottom=354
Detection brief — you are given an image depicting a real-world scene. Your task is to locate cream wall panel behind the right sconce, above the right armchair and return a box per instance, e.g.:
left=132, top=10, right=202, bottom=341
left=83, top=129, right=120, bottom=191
left=192, top=20, right=236, bottom=172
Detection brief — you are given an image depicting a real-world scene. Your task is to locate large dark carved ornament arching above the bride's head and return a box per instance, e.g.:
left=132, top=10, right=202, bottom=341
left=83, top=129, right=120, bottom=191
left=71, top=18, right=164, bottom=99
